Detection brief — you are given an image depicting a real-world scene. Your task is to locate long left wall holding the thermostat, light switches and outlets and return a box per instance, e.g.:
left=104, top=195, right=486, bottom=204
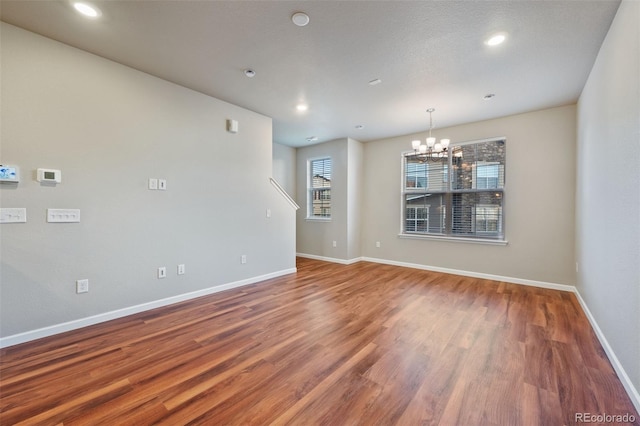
left=0, top=24, right=295, bottom=337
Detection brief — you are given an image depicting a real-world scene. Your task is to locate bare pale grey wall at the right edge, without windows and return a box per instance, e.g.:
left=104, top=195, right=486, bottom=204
left=576, top=0, right=640, bottom=409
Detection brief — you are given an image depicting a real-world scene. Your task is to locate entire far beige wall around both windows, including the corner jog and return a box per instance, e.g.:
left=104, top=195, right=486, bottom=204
left=297, top=105, right=576, bottom=285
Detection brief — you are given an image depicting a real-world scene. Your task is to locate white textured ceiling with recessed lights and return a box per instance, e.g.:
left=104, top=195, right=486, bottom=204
left=0, top=0, right=620, bottom=146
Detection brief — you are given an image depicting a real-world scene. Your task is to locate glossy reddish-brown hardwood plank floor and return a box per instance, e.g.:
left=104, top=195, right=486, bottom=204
left=0, top=259, right=640, bottom=425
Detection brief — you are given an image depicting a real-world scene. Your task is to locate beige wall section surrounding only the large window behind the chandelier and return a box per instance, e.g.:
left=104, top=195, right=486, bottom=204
left=362, top=106, right=576, bottom=285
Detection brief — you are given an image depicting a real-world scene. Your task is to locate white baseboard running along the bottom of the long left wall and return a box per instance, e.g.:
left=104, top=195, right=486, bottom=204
left=0, top=268, right=296, bottom=348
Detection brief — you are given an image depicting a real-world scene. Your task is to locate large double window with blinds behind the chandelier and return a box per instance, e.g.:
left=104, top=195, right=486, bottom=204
left=402, top=139, right=506, bottom=240
